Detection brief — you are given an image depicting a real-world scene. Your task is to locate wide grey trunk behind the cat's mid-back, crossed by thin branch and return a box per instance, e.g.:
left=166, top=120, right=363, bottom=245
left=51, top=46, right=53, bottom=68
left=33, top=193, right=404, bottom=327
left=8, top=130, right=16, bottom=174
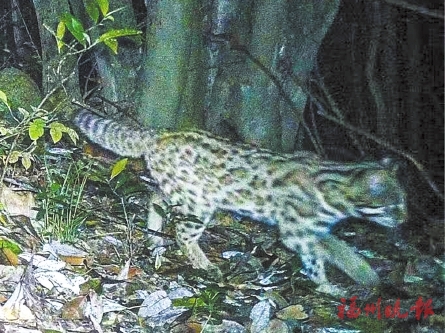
left=207, top=1, right=339, bottom=151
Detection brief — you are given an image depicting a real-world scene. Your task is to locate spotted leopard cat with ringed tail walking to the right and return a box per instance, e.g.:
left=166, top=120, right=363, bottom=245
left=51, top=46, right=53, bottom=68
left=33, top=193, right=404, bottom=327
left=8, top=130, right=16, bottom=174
left=74, top=110, right=406, bottom=292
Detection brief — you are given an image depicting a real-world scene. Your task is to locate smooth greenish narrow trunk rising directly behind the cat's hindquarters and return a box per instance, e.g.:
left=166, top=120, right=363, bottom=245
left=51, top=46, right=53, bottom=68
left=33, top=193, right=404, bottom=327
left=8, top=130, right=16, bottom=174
left=135, top=0, right=206, bottom=128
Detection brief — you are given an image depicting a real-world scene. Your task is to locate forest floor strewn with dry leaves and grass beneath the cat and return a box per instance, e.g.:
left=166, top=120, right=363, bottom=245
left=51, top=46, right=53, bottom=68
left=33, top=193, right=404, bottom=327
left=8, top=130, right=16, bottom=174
left=0, top=147, right=445, bottom=332
